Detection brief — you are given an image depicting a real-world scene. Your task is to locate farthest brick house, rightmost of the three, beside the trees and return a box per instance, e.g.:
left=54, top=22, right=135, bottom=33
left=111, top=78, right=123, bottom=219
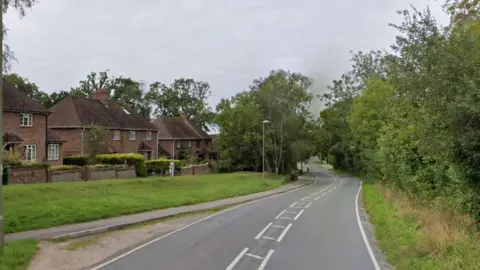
left=153, top=114, right=213, bottom=159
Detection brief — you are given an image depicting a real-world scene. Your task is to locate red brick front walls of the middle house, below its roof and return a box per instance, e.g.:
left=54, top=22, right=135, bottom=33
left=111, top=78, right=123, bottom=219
left=55, top=129, right=158, bottom=159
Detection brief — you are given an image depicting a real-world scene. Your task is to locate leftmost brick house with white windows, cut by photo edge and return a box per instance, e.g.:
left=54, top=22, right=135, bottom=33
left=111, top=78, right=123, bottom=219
left=3, top=82, right=63, bottom=165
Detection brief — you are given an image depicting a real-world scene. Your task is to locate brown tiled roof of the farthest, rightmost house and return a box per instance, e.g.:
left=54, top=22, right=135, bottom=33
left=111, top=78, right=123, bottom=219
left=153, top=116, right=211, bottom=139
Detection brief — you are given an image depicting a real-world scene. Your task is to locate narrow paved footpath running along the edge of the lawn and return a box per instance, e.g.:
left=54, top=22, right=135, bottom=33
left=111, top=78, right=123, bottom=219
left=5, top=177, right=314, bottom=241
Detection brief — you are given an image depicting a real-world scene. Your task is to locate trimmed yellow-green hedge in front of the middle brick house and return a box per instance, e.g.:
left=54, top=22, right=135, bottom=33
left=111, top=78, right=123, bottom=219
left=95, top=153, right=147, bottom=177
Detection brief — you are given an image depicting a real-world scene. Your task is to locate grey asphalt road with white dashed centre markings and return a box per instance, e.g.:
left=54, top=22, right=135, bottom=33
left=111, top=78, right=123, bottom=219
left=87, top=172, right=383, bottom=270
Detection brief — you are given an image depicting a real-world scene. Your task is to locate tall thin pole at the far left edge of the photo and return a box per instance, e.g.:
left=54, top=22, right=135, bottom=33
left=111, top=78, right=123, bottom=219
left=0, top=1, right=5, bottom=251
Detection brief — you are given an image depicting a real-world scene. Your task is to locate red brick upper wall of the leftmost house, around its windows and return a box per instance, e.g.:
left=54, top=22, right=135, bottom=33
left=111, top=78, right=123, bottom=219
left=3, top=112, right=47, bottom=162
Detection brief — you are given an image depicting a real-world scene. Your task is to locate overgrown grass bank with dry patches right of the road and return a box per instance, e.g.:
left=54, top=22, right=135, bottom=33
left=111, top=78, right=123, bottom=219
left=363, top=184, right=480, bottom=270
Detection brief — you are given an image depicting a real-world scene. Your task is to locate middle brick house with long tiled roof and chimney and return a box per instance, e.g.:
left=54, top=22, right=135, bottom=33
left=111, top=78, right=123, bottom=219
left=48, top=89, right=158, bottom=159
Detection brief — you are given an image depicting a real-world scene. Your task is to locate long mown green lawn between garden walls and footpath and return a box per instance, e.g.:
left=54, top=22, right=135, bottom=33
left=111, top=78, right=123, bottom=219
left=4, top=173, right=283, bottom=233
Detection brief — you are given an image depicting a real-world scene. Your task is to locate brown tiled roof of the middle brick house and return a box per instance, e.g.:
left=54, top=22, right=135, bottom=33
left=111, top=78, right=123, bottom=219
left=48, top=96, right=157, bottom=131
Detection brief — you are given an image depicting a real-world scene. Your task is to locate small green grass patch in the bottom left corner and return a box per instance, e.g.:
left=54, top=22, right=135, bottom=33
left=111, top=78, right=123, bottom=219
left=0, top=240, right=38, bottom=270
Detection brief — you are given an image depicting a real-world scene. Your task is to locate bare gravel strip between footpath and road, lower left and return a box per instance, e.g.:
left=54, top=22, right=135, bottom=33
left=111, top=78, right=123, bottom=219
left=28, top=213, right=212, bottom=270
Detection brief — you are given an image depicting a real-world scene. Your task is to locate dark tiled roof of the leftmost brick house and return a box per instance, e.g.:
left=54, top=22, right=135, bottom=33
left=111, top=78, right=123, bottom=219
left=3, top=82, right=50, bottom=113
